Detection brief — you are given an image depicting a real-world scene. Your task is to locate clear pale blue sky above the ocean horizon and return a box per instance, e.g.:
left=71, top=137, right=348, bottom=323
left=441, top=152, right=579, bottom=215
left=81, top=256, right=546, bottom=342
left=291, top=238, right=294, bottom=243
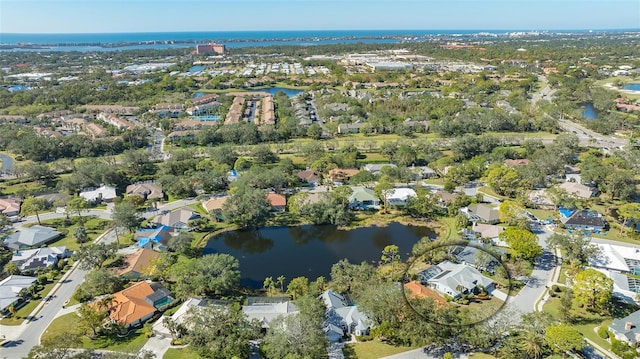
left=0, top=0, right=640, bottom=33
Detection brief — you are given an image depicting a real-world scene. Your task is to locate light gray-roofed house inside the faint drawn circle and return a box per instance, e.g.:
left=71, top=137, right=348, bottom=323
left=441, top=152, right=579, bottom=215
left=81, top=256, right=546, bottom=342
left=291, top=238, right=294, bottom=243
left=423, top=261, right=494, bottom=299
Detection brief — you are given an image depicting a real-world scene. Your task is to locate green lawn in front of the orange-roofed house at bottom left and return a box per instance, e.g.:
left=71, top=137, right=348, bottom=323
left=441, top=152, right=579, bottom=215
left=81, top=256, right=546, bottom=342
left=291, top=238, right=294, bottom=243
left=41, top=313, right=147, bottom=353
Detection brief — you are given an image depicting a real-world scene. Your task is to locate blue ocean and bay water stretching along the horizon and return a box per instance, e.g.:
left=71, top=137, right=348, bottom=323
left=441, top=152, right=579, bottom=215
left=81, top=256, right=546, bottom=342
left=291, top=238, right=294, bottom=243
left=0, top=29, right=638, bottom=52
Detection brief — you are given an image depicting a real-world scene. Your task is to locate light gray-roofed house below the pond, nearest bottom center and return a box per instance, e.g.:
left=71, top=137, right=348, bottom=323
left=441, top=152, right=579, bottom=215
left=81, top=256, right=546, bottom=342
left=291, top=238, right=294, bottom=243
left=320, top=289, right=371, bottom=342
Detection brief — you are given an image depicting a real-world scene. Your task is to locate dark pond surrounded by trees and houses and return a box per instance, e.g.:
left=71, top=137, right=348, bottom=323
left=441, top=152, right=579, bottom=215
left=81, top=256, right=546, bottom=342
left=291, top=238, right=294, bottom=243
left=204, top=223, right=435, bottom=288
